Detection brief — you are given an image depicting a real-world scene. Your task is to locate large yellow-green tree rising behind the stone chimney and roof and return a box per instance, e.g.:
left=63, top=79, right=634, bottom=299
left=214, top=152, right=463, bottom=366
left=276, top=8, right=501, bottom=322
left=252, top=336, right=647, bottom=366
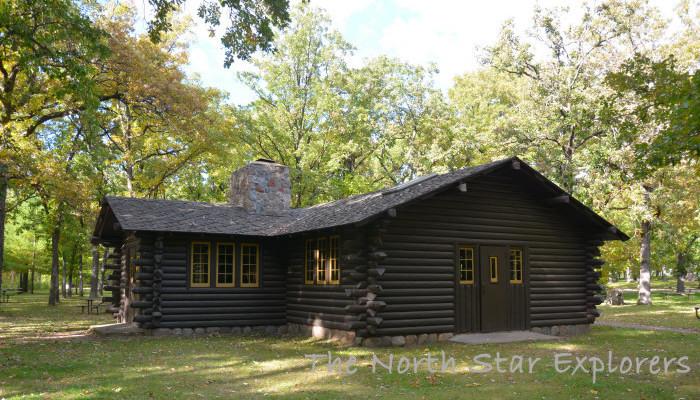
left=231, top=4, right=462, bottom=207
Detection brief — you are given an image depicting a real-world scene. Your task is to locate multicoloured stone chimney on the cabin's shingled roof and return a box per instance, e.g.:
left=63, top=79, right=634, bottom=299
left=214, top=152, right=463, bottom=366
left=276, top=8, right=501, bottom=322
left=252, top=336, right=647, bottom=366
left=229, top=158, right=292, bottom=214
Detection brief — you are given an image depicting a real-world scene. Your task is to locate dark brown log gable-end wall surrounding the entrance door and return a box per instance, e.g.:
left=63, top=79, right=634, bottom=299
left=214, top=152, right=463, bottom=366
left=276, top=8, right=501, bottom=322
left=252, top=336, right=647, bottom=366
left=369, top=171, right=599, bottom=335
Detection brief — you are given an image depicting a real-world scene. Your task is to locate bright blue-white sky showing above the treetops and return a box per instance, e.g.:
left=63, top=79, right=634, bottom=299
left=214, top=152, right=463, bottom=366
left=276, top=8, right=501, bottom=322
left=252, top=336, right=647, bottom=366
left=135, top=0, right=676, bottom=104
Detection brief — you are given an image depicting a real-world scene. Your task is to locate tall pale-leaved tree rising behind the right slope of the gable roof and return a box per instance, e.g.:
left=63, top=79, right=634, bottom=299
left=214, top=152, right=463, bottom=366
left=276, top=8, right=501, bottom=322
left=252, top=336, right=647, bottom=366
left=484, top=1, right=658, bottom=192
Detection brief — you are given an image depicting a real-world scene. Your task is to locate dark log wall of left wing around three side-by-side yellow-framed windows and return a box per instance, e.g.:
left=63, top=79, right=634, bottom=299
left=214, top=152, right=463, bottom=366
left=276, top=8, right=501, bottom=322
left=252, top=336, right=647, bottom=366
left=133, top=233, right=286, bottom=328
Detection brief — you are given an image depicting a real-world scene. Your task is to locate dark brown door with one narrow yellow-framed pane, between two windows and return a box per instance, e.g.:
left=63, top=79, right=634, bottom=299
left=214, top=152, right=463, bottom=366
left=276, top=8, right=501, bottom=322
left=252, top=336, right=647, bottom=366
left=478, top=246, right=510, bottom=332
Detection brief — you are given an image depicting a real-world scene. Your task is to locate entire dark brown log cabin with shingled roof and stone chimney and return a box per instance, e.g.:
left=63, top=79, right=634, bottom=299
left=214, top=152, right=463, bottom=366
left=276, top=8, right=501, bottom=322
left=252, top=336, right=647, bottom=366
left=92, top=157, right=629, bottom=345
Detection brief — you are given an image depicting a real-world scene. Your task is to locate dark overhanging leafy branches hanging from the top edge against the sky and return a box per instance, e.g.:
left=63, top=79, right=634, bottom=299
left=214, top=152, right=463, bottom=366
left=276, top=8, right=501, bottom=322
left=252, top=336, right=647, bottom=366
left=148, top=0, right=289, bottom=67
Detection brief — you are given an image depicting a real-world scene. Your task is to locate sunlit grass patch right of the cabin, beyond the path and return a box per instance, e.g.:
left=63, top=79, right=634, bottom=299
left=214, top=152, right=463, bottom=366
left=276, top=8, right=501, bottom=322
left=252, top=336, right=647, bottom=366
left=598, top=293, right=700, bottom=328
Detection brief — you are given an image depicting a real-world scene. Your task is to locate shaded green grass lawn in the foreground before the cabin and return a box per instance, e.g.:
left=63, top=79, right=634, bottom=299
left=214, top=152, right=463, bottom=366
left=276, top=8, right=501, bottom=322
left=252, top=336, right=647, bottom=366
left=0, top=294, right=700, bottom=399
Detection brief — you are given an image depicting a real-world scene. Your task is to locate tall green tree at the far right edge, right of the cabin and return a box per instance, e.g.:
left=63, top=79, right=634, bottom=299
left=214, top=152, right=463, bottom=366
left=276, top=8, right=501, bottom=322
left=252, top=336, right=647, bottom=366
left=602, top=2, right=700, bottom=304
